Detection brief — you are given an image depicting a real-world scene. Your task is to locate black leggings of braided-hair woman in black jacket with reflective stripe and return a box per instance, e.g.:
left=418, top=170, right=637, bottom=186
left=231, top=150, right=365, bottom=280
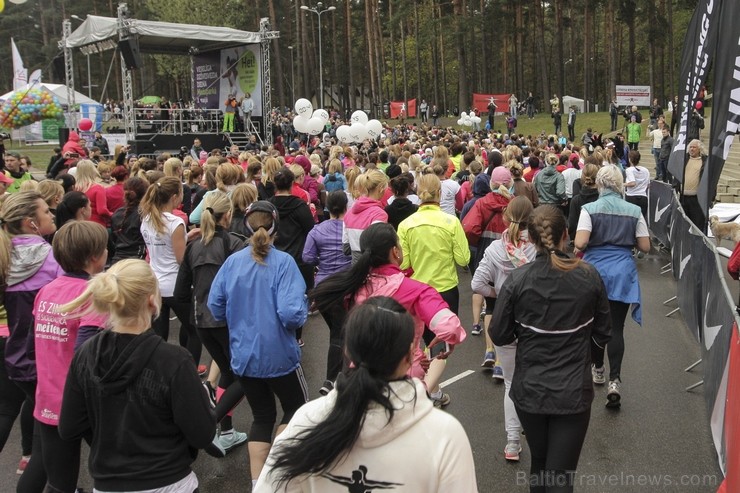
left=516, top=406, right=591, bottom=493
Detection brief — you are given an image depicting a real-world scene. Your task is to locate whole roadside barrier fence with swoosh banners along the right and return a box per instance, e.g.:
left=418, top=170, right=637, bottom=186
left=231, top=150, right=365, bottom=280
left=647, top=181, right=740, bottom=492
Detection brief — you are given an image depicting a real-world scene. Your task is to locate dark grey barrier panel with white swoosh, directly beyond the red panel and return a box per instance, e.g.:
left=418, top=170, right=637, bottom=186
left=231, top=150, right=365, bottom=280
left=692, top=237, right=735, bottom=409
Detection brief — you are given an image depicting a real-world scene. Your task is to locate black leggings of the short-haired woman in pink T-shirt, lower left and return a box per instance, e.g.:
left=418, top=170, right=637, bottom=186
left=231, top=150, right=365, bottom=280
left=17, top=421, right=81, bottom=493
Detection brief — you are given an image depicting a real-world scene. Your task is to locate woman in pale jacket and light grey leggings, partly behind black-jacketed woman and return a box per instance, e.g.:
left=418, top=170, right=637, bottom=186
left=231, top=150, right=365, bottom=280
left=470, top=196, right=537, bottom=461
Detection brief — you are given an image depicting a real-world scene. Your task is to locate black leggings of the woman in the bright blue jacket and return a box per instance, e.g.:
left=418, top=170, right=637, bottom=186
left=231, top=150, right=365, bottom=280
left=237, top=365, right=308, bottom=443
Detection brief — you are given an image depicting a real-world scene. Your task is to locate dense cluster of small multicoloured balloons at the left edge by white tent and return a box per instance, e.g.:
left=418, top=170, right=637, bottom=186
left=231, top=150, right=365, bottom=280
left=0, top=89, right=64, bottom=128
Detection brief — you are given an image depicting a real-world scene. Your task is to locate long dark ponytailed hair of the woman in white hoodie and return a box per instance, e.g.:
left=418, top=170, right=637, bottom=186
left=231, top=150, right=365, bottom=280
left=268, top=296, right=414, bottom=484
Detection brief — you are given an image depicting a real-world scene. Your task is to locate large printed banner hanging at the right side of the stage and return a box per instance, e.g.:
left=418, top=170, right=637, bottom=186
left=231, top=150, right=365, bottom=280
left=193, top=44, right=262, bottom=116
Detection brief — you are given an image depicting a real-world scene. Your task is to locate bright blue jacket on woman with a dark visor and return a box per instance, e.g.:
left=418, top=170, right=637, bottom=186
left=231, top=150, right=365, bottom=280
left=208, top=246, right=308, bottom=378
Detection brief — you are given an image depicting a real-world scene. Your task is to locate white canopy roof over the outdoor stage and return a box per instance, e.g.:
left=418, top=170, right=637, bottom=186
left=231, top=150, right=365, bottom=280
left=67, top=15, right=261, bottom=55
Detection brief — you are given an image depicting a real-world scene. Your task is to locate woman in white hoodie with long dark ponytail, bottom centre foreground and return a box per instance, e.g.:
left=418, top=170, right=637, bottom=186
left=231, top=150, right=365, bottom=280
left=254, top=296, right=478, bottom=493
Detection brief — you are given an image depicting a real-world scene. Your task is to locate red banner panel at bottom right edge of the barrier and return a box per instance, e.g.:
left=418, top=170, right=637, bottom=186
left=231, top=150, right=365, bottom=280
left=720, top=325, right=740, bottom=491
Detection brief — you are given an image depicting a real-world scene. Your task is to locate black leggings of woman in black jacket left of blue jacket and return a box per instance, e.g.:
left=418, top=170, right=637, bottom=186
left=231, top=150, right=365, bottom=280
left=198, top=327, right=244, bottom=431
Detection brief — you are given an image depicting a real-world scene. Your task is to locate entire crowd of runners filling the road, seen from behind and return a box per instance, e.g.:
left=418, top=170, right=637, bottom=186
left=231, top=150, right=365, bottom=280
left=0, top=111, right=662, bottom=493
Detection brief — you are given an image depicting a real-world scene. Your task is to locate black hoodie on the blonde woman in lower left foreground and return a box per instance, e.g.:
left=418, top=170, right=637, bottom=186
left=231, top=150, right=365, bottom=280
left=59, top=330, right=216, bottom=491
